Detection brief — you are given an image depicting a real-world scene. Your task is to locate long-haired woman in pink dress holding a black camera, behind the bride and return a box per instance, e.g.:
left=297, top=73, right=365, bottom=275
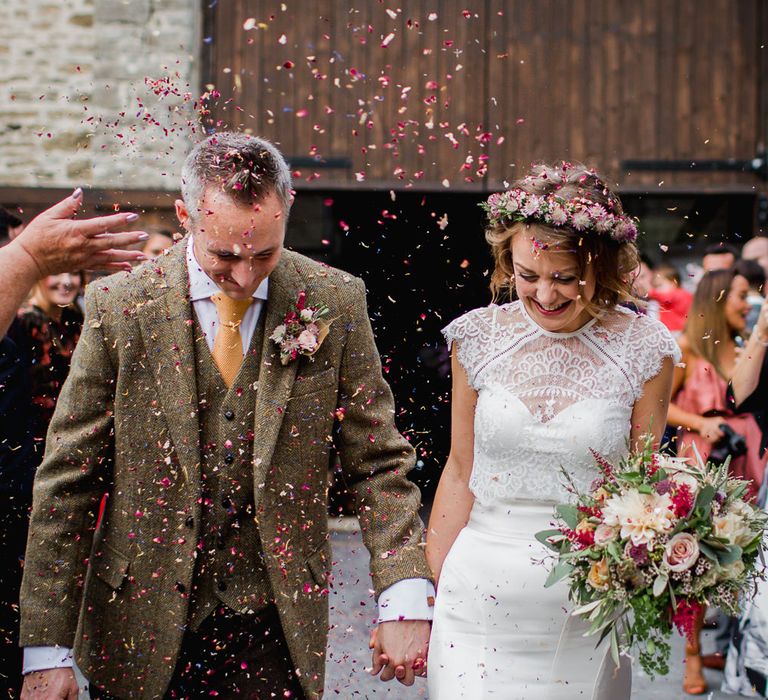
left=667, top=270, right=765, bottom=695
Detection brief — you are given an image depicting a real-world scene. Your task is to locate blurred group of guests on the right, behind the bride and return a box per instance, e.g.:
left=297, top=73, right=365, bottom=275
left=635, top=237, right=768, bottom=697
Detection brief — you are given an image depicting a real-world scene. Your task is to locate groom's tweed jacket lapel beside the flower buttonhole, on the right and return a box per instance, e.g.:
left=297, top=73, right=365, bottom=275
left=253, top=251, right=306, bottom=492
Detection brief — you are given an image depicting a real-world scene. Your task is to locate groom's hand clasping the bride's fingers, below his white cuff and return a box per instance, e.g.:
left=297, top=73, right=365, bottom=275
left=369, top=620, right=430, bottom=685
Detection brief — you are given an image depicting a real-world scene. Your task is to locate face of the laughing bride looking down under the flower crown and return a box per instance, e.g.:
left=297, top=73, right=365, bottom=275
left=512, top=229, right=595, bottom=333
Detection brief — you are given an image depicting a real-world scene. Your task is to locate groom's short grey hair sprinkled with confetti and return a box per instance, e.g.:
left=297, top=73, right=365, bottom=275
left=181, top=131, right=293, bottom=219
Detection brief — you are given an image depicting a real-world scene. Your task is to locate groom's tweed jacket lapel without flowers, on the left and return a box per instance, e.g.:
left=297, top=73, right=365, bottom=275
left=138, top=238, right=200, bottom=489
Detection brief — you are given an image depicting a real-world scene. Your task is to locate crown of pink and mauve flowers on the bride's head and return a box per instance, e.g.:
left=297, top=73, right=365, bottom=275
left=480, top=187, right=637, bottom=243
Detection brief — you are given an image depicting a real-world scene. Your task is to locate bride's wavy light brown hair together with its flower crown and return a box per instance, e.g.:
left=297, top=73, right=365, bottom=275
left=481, top=162, right=640, bottom=316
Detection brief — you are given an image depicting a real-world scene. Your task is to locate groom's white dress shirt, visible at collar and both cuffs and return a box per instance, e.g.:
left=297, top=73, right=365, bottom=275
left=23, top=236, right=435, bottom=678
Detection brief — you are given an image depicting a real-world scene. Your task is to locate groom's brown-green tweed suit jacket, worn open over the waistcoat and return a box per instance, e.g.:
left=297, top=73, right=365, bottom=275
left=21, top=242, right=431, bottom=698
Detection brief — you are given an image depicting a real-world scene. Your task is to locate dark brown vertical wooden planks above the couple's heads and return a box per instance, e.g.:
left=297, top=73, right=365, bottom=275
left=204, top=0, right=768, bottom=191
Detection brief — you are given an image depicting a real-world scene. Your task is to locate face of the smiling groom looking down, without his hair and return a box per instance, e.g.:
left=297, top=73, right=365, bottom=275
left=176, top=189, right=286, bottom=299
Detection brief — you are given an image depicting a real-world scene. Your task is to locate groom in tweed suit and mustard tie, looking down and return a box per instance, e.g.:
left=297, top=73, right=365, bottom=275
left=21, top=133, right=431, bottom=698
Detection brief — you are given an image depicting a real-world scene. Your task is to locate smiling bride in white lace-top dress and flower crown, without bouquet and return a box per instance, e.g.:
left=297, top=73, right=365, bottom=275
left=427, top=163, right=678, bottom=700
